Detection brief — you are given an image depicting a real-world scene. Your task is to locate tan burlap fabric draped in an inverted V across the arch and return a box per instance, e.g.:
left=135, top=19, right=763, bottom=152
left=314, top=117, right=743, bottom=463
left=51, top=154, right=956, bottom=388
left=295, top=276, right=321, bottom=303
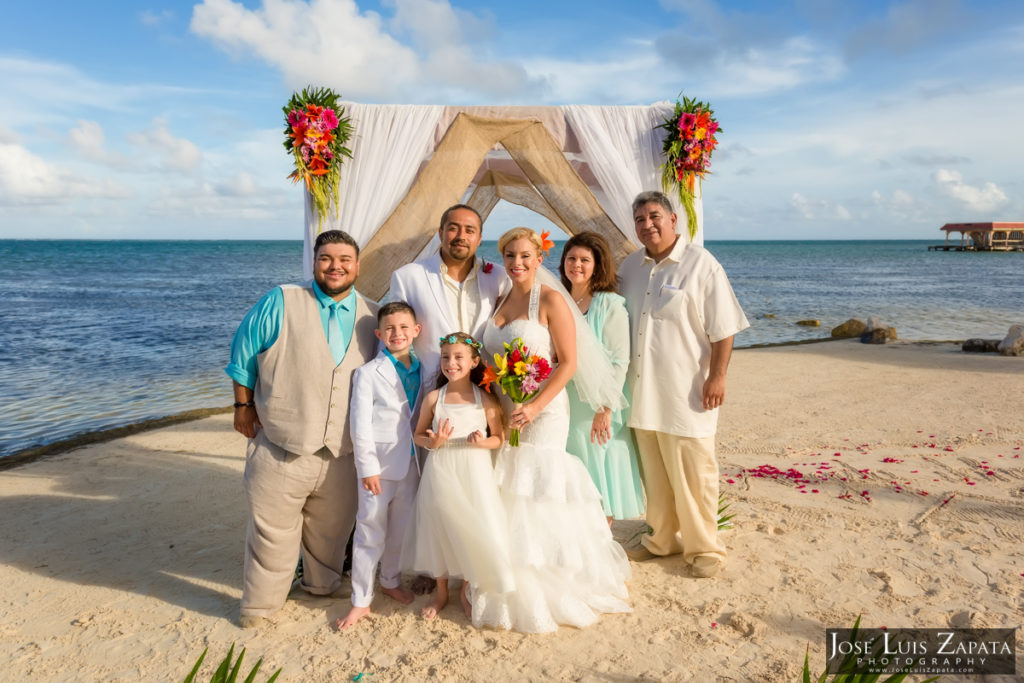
left=356, top=114, right=634, bottom=299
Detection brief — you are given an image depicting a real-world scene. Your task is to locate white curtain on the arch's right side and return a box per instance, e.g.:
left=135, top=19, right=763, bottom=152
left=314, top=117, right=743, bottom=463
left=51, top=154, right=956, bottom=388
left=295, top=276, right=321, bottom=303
left=561, top=102, right=703, bottom=246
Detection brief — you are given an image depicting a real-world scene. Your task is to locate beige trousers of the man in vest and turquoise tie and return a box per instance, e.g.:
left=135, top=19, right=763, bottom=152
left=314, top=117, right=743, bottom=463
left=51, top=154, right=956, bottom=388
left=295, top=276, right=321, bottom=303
left=241, top=430, right=357, bottom=616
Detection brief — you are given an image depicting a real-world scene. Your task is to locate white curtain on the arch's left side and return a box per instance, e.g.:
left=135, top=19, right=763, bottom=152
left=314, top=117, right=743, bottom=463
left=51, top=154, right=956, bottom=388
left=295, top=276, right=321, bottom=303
left=302, top=102, right=444, bottom=280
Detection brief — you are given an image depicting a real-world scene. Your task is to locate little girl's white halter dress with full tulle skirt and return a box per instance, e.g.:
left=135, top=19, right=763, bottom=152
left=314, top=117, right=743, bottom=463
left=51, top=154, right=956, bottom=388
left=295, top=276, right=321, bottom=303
left=401, top=387, right=515, bottom=602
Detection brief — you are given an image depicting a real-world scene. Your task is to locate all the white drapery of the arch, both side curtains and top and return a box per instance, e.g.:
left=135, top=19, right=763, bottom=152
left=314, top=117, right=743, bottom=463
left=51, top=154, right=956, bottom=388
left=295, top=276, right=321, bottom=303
left=303, top=102, right=703, bottom=279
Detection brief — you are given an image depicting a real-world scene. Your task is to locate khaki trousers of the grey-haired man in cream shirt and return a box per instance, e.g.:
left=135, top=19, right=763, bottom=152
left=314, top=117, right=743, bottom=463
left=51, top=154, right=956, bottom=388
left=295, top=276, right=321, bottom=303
left=634, top=429, right=725, bottom=563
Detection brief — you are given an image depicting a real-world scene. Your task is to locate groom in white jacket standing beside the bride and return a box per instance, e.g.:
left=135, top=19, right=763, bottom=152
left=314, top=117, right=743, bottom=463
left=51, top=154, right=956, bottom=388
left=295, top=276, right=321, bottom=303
left=385, top=204, right=510, bottom=394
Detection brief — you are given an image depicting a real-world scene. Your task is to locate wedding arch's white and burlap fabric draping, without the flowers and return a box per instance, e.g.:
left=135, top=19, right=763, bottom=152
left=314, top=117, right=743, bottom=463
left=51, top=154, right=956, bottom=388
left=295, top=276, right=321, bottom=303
left=303, top=102, right=703, bottom=299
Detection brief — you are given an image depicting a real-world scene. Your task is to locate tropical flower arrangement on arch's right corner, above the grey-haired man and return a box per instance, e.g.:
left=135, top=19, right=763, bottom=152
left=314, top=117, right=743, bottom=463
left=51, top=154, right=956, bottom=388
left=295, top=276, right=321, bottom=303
left=656, top=95, right=722, bottom=242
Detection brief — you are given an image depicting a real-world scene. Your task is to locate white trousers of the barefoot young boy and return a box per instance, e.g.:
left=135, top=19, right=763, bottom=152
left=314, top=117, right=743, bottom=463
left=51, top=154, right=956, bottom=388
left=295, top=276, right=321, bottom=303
left=352, top=459, right=420, bottom=607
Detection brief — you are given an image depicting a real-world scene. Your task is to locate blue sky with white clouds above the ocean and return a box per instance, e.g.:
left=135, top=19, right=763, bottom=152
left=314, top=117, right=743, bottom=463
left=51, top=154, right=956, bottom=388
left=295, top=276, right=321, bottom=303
left=0, top=0, right=1024, bottom=243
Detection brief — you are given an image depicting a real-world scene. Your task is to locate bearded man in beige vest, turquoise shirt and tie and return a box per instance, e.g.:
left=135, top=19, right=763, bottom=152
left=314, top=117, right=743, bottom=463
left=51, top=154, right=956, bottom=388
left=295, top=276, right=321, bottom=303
left=224, top=230, right=378, bottom=628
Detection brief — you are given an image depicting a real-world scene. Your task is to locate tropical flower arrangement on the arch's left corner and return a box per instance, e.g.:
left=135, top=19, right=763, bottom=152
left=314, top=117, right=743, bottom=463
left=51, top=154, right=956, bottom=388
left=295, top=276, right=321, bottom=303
left=284, top=87, right=352, bottom=228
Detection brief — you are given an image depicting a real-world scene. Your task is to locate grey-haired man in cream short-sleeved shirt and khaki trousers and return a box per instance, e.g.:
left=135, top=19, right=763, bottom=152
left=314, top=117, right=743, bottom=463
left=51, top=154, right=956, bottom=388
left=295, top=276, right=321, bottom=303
left=618, top=193, right=750, bottom=578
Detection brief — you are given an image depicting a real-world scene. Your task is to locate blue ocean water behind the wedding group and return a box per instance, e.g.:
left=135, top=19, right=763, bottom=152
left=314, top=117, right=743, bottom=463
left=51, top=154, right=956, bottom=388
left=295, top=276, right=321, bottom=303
left=0, top=241, right=1024, bottom=457
